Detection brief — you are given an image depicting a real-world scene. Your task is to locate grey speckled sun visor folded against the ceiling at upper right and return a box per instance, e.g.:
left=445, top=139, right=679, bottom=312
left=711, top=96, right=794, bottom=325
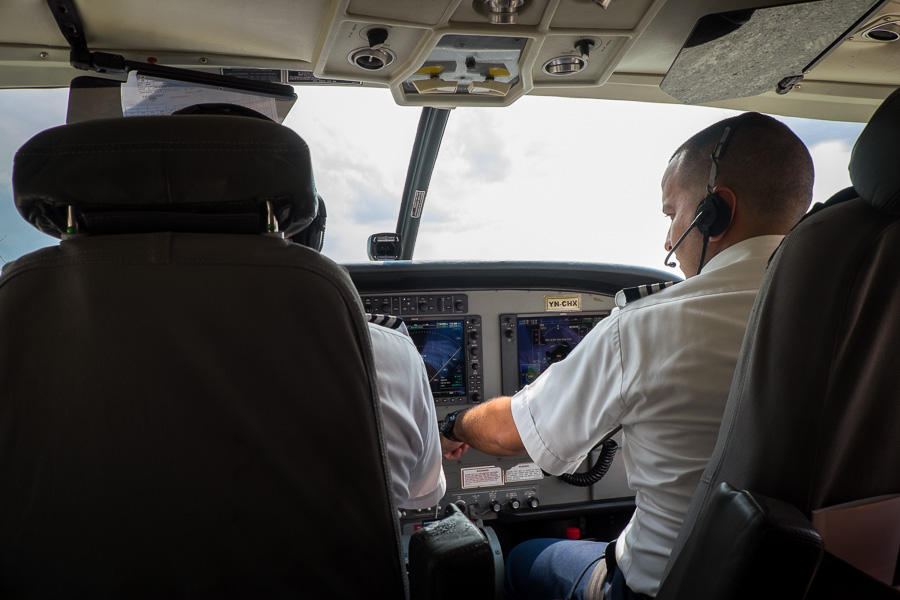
left=659, top=0, right=882, bottom=104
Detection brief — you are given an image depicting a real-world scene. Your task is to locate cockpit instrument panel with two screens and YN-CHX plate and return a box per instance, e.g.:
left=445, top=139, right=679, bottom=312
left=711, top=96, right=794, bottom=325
left=348, top=263, right=671, bottom=533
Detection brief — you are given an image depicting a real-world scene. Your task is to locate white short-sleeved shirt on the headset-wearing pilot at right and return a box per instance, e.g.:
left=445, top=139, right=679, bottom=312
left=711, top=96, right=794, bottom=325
left=512, top=236, right=782, bottom=596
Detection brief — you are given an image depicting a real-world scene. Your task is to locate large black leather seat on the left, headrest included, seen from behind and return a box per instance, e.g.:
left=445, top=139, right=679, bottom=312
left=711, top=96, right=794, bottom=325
left=0, top=116, right=408, bottom=598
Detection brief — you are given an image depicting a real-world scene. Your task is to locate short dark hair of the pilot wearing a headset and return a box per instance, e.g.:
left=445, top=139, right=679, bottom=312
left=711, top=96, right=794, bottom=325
left=672, top=112, right=814, bottom=226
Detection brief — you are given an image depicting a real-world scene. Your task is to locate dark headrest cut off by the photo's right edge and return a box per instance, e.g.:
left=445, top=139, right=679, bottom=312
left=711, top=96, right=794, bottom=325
left=850, top=89, right=900, bottom=214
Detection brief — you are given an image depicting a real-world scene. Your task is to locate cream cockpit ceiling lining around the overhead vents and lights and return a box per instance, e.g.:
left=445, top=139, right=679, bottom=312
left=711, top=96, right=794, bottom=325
left=0, top=0, right=900, bottom=120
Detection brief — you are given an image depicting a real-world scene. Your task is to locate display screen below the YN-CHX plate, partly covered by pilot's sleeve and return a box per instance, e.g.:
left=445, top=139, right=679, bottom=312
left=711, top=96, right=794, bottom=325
left=516, top=313, right=606, bottom=389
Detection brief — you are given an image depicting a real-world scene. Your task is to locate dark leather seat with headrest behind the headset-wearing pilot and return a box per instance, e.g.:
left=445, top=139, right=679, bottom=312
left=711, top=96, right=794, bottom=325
left=657, top=92, right=900, bottom=599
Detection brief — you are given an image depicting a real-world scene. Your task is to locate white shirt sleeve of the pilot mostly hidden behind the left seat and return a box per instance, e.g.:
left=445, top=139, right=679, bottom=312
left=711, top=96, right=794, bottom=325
left=369, top=323, right=447, bottom=508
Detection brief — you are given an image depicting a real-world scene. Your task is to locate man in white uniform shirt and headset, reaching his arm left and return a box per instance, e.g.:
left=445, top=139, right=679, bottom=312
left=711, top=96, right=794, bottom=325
left=441, top=113, right=813, bottom=600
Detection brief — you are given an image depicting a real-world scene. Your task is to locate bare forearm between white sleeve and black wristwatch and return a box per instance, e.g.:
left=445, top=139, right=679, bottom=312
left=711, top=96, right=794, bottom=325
left=453, top=396, right=525, bottom=456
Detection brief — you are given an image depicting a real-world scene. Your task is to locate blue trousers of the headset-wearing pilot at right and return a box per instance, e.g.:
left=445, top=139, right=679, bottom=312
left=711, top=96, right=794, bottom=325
left=503, top=539, right=646, bottom=600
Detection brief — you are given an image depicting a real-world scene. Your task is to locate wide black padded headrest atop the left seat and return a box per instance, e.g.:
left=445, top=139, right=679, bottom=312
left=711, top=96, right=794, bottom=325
left=13, top=115, right=317, bottom=237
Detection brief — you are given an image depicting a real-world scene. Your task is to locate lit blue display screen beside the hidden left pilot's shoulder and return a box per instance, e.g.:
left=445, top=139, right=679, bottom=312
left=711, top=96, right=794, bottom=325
left=406, top=319, right=466, bottom=398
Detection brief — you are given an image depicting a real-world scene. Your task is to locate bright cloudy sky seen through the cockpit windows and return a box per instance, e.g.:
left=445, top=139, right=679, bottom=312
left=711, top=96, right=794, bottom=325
left=0, top=87, right=863, bottom=275
